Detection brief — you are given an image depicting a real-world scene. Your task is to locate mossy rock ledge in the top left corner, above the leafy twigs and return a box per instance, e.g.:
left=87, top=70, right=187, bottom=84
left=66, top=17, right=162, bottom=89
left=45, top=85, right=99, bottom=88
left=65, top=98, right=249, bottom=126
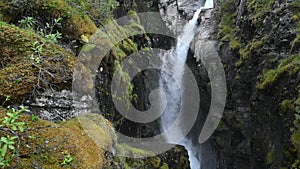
left=0, top=0, right=97, bottom=39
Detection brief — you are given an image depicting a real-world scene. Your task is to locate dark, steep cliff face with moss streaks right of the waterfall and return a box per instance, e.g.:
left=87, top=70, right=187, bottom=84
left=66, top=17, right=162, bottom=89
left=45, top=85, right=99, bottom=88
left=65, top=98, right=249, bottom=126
left=202, top=0, right=300, bottom=169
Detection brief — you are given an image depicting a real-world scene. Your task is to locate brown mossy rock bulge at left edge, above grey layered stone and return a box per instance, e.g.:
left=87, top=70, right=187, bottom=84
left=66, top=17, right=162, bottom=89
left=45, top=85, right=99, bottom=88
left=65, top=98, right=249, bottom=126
left=0, top=22, right=74, bottom=101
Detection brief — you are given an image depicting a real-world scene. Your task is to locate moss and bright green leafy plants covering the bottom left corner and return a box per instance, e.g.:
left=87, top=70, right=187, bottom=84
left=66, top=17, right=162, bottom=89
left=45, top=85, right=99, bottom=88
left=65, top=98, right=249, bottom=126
left=0, top=107, right=115, bottom=169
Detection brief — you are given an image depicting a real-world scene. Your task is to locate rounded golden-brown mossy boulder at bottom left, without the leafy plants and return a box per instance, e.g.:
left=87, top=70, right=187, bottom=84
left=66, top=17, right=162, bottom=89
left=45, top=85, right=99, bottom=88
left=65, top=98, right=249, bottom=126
left=0, top=109, right=116, bottom=169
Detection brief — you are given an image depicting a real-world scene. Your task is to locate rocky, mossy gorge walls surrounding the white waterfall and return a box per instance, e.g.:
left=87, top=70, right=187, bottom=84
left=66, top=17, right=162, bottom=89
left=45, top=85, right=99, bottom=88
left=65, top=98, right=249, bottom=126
left=0, top=0, right=300, bottom=169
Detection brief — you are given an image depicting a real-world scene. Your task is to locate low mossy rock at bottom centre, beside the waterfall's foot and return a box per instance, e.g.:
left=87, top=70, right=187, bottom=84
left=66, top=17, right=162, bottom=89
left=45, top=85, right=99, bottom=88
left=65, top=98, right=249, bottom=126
left=105, top=144, right=190, bottom=169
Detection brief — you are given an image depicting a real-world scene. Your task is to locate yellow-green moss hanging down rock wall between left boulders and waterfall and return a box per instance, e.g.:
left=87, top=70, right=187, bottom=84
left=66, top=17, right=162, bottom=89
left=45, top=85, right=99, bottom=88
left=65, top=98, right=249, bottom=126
left=81, top=15, right=150, bottom=116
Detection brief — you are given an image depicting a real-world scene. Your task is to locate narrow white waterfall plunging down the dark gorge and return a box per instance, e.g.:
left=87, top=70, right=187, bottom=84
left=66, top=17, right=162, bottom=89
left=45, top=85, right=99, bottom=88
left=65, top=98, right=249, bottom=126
left=160, top=0, right=213, bottom=169
